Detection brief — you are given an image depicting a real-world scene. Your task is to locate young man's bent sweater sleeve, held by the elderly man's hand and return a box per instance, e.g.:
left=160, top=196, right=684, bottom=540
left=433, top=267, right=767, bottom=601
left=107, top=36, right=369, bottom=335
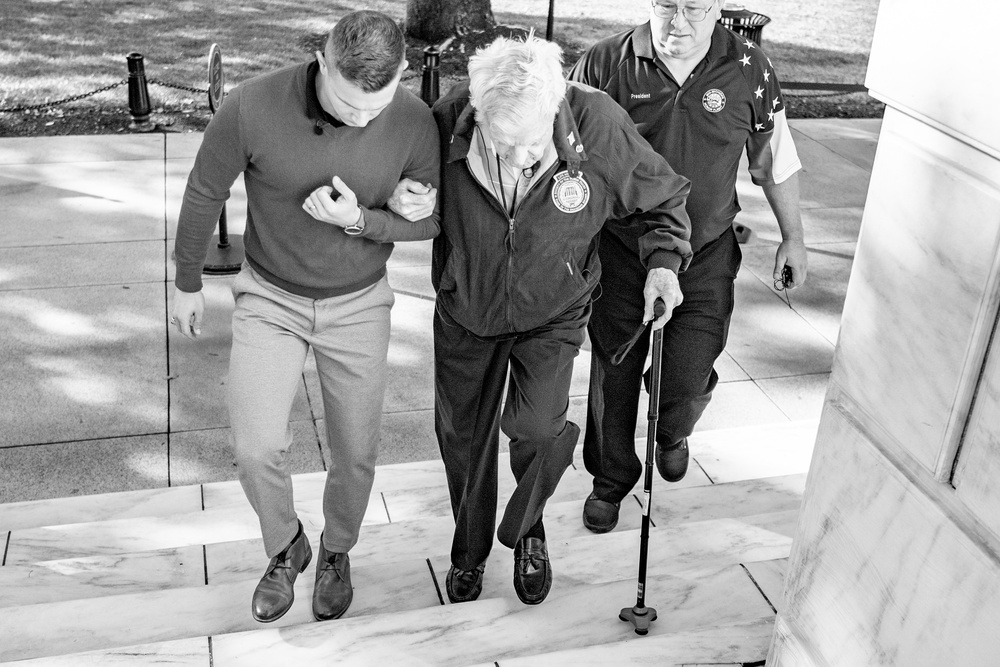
left=362, top=103, right=441, bottom=243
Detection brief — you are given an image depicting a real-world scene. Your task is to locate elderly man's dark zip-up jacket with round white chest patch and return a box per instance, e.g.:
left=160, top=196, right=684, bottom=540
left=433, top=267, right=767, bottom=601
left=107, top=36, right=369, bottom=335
left=431, top=83, right=691, bottom=337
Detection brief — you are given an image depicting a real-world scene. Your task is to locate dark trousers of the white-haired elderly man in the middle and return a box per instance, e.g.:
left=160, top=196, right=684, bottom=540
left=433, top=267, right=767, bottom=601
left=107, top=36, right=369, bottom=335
left=434, top=295, right=590, bottom=570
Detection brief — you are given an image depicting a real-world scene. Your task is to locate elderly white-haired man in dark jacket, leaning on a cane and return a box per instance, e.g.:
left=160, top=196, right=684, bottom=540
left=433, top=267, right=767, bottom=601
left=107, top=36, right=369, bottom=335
left=410, top=35, right=691, bottom=604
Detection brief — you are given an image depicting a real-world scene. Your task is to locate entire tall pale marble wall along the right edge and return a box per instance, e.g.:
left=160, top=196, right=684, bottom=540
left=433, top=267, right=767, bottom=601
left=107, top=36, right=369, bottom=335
left=768, top=0, right=1000, bottom=667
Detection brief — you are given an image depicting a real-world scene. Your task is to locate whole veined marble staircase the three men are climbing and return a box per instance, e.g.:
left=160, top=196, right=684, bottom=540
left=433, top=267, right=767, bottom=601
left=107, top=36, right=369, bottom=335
left=0, top=421, right=816, bottom=667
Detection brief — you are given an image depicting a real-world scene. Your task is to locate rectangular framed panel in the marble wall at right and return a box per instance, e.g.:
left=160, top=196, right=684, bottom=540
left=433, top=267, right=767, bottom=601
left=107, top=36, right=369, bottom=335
left=832, top=107, right=1000, bottom=479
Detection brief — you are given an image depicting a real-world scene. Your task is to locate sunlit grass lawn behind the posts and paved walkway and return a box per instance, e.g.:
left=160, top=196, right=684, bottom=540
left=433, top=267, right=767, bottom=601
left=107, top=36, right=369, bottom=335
left=0, top=0, right=878, bottom=136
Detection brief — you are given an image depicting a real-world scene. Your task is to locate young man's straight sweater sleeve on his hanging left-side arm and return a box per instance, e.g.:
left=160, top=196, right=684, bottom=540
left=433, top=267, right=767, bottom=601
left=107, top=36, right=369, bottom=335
left=174, top=88, right=248, bottom=292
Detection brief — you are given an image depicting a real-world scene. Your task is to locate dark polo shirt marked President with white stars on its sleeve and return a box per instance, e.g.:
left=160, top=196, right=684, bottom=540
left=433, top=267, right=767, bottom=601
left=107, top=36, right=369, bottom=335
left=569, top=23, right=802, bottom=252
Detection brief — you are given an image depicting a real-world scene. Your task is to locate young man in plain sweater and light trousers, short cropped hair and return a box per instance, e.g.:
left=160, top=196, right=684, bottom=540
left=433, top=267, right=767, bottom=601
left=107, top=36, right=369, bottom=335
left=171, top=11, right=440, bottom=622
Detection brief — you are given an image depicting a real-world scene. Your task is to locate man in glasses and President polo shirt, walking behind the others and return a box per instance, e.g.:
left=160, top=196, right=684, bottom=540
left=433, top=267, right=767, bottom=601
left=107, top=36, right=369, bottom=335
left=569, top=0, right=807, bottom=533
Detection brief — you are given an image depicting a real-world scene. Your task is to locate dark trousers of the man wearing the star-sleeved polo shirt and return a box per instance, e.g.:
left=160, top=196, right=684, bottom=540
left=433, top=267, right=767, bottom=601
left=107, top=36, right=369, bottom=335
left=583, top=228, right=742, bottom=501
